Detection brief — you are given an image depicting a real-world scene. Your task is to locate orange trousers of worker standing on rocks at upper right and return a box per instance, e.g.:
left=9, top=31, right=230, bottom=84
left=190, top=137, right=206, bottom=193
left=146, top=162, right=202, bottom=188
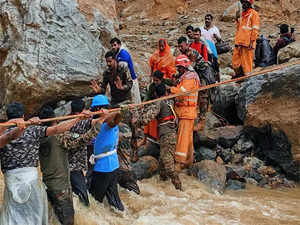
left=232, top=46, right=254, bottom=75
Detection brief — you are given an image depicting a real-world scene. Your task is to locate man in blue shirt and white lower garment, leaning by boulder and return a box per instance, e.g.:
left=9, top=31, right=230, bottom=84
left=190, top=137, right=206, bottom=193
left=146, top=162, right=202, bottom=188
left=110, top=38, right=141, bottom=104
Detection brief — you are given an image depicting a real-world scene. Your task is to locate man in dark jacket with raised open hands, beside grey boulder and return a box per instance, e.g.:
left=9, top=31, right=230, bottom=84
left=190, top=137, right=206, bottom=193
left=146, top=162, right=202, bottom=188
left=91, top=51, right=133, bottom=108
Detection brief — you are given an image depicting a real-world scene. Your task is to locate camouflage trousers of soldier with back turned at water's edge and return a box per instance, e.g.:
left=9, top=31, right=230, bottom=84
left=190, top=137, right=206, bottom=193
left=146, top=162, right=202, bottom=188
left=159, top=132, right=177, bottom=178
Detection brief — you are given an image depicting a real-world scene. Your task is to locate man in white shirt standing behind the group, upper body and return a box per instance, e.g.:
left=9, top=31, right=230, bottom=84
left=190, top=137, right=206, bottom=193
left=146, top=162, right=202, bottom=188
left=201, top=14, right=222, bottom=43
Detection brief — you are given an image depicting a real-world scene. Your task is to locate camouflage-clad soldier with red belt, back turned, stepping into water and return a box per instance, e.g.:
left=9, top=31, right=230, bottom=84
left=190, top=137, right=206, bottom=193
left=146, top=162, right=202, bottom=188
left=132, top=83, right=182, bottom=190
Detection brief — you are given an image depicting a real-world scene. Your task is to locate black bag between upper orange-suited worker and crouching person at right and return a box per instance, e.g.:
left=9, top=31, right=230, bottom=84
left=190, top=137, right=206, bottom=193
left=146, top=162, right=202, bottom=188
left=254, top=35, right=275, bottom=67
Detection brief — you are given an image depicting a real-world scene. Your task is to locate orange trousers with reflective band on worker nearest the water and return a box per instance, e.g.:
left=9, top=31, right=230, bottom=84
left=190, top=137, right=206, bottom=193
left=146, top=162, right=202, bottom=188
left=175, top=119, right=194, bottom=166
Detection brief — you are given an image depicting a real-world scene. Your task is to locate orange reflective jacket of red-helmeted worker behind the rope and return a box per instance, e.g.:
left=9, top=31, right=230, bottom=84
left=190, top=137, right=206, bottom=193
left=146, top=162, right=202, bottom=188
left=171, top=71, right=200, bottom=119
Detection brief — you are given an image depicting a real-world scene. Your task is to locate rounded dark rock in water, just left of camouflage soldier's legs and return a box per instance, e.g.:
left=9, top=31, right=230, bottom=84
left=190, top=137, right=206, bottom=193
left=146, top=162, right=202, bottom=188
left=131, top=156, right=159, bottom=180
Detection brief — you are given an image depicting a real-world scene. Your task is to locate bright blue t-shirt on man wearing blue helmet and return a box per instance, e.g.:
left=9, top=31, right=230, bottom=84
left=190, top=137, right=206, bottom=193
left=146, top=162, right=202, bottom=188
left=94, top=123, right=119, bottom=172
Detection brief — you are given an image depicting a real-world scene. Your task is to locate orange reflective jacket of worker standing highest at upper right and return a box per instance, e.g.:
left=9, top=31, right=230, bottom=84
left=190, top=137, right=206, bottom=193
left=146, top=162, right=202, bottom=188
left=234, top=8, right=259, bottom=49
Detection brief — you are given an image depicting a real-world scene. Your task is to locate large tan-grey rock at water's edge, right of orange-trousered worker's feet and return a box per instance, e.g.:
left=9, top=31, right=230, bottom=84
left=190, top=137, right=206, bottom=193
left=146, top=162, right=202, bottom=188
left=189, top=160, right=226, bottom=194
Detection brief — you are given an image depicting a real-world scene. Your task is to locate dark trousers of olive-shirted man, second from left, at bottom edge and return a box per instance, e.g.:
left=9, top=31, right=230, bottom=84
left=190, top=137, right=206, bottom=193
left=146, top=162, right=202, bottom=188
left=46, top=188, right=74, bottom=225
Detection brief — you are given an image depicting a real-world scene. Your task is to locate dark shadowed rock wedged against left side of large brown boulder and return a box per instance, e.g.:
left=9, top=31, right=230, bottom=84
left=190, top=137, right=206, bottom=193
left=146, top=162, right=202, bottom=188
left=212, top=83, right=241, bottom=124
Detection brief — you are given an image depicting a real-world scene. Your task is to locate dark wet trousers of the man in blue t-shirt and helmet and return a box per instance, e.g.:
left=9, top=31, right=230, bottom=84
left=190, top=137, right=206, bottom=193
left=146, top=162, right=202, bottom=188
left=90, top=170, right=124, bottom=211
